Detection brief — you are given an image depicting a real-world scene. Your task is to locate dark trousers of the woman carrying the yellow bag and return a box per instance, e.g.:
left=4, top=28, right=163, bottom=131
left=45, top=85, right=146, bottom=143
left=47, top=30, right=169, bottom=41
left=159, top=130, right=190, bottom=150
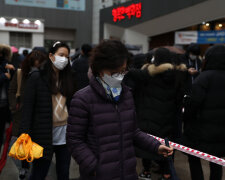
left=29, top=145, right=71, bottom=180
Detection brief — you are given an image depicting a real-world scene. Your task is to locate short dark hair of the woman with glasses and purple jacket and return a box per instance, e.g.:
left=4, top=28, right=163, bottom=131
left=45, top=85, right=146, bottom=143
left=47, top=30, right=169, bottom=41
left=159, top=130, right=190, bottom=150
left=90, top=40, right=130, bottom=77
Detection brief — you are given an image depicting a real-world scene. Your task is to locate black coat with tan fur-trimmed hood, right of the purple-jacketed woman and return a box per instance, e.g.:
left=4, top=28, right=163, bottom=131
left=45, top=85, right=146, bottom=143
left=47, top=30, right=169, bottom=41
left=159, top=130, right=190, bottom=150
left=125, top=63, right=187, bottom=137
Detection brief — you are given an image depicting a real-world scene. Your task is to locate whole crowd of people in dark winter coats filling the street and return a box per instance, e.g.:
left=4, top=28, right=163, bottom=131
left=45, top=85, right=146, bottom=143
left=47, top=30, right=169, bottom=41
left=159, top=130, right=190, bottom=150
left=0, top=40, right=225, bottom=180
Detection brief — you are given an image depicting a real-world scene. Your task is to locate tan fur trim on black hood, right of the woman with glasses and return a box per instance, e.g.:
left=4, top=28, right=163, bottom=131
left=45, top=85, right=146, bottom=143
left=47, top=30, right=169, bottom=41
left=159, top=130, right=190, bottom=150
left=141, top=63, right=187, bottom=76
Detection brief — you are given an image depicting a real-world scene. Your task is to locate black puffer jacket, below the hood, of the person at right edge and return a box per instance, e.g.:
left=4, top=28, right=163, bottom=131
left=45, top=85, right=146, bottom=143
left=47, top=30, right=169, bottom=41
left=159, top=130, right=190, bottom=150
left=183, top=69, right=225, bottom=157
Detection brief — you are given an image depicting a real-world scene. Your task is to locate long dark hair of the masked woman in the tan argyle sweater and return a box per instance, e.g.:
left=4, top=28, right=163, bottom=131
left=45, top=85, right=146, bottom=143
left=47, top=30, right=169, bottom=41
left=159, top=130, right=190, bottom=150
left=44, top=42, right=75, bottom=98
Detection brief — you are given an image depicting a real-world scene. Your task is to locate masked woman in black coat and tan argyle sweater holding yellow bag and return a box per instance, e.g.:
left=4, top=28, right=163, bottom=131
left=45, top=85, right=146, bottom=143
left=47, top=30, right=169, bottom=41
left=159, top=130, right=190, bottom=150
left=20, top=42, right=75, bottom=180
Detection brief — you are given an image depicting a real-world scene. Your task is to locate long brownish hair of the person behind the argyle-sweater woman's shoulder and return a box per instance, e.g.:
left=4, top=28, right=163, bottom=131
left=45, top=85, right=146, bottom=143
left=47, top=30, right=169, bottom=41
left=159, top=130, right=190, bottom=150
left=21, top=50, right=47, bottom=78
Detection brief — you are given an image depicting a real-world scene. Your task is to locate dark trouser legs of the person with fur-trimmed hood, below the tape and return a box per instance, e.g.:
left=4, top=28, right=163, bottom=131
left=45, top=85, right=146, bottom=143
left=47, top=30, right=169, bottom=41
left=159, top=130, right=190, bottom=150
left=142, top=159, right=170, bottom=174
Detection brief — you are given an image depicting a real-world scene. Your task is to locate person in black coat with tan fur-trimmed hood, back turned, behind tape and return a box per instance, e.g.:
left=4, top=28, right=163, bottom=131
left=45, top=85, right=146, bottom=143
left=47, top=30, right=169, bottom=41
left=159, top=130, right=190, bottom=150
left=124, top=48, right=187, bottom=179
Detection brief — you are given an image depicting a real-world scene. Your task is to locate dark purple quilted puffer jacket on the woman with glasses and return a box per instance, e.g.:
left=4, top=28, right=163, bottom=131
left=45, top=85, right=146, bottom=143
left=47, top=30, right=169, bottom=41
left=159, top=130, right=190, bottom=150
left=67, top=78, right=160, bottom=180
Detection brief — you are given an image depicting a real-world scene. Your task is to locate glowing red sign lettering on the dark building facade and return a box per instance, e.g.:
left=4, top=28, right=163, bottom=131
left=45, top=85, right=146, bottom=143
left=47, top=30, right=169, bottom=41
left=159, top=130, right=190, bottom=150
left=112, top=3, right=142, bottom=22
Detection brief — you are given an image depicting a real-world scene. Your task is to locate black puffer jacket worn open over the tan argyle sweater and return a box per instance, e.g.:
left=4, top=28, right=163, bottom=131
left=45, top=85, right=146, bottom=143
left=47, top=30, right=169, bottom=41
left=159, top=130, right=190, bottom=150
left=19, top=65, right=75, bottom=159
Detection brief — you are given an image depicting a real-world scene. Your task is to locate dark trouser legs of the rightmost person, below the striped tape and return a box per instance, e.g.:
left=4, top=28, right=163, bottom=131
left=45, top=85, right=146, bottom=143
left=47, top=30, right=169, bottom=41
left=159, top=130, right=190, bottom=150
left=188, top=156, right=223, bottom=180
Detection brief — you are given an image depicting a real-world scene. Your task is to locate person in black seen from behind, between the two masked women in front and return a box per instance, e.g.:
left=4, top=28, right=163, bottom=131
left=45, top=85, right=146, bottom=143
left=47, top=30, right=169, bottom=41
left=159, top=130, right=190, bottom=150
left=72, top=44, right=92, bottom=90
